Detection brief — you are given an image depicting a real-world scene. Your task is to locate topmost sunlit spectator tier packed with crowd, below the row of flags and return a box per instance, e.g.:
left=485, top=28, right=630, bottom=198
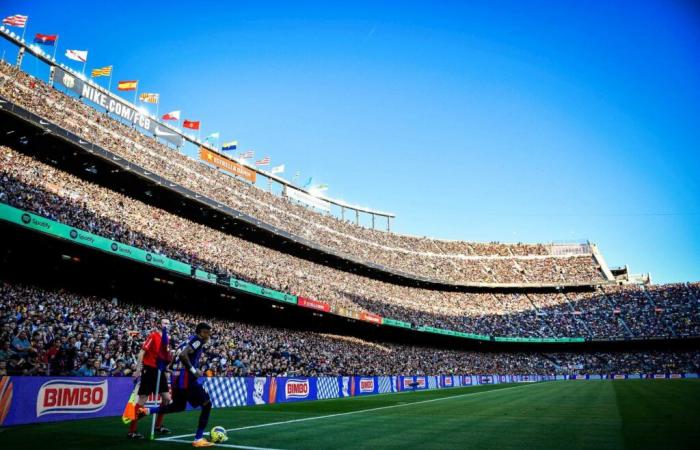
left=0, top=59, right=607, bottom=284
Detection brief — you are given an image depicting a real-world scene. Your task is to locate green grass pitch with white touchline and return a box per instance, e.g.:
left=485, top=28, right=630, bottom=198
left=0, top=380, right=700, bottom=450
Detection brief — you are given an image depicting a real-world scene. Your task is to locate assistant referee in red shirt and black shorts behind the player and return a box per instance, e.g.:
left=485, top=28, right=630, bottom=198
left=127, top=319, right=170, bottom=439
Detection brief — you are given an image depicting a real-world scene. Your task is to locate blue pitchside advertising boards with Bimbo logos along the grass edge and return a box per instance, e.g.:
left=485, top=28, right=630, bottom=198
left=0, top=373, right=698, bottom=426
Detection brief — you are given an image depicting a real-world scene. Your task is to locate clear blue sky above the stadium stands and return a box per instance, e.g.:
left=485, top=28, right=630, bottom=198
left=0, top=1, right=700, bottom=282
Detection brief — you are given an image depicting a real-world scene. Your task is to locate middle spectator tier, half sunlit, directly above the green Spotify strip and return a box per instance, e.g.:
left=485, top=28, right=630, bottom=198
left=0, top=146, right=700, bottom=339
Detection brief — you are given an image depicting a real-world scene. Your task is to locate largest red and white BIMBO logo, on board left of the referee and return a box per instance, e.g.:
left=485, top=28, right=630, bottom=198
left=36, top=380, right=108, bottom=417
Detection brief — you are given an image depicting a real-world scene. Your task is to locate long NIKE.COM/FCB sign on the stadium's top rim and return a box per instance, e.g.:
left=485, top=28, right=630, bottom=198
left=53, top=67, right=184, bottom=147
